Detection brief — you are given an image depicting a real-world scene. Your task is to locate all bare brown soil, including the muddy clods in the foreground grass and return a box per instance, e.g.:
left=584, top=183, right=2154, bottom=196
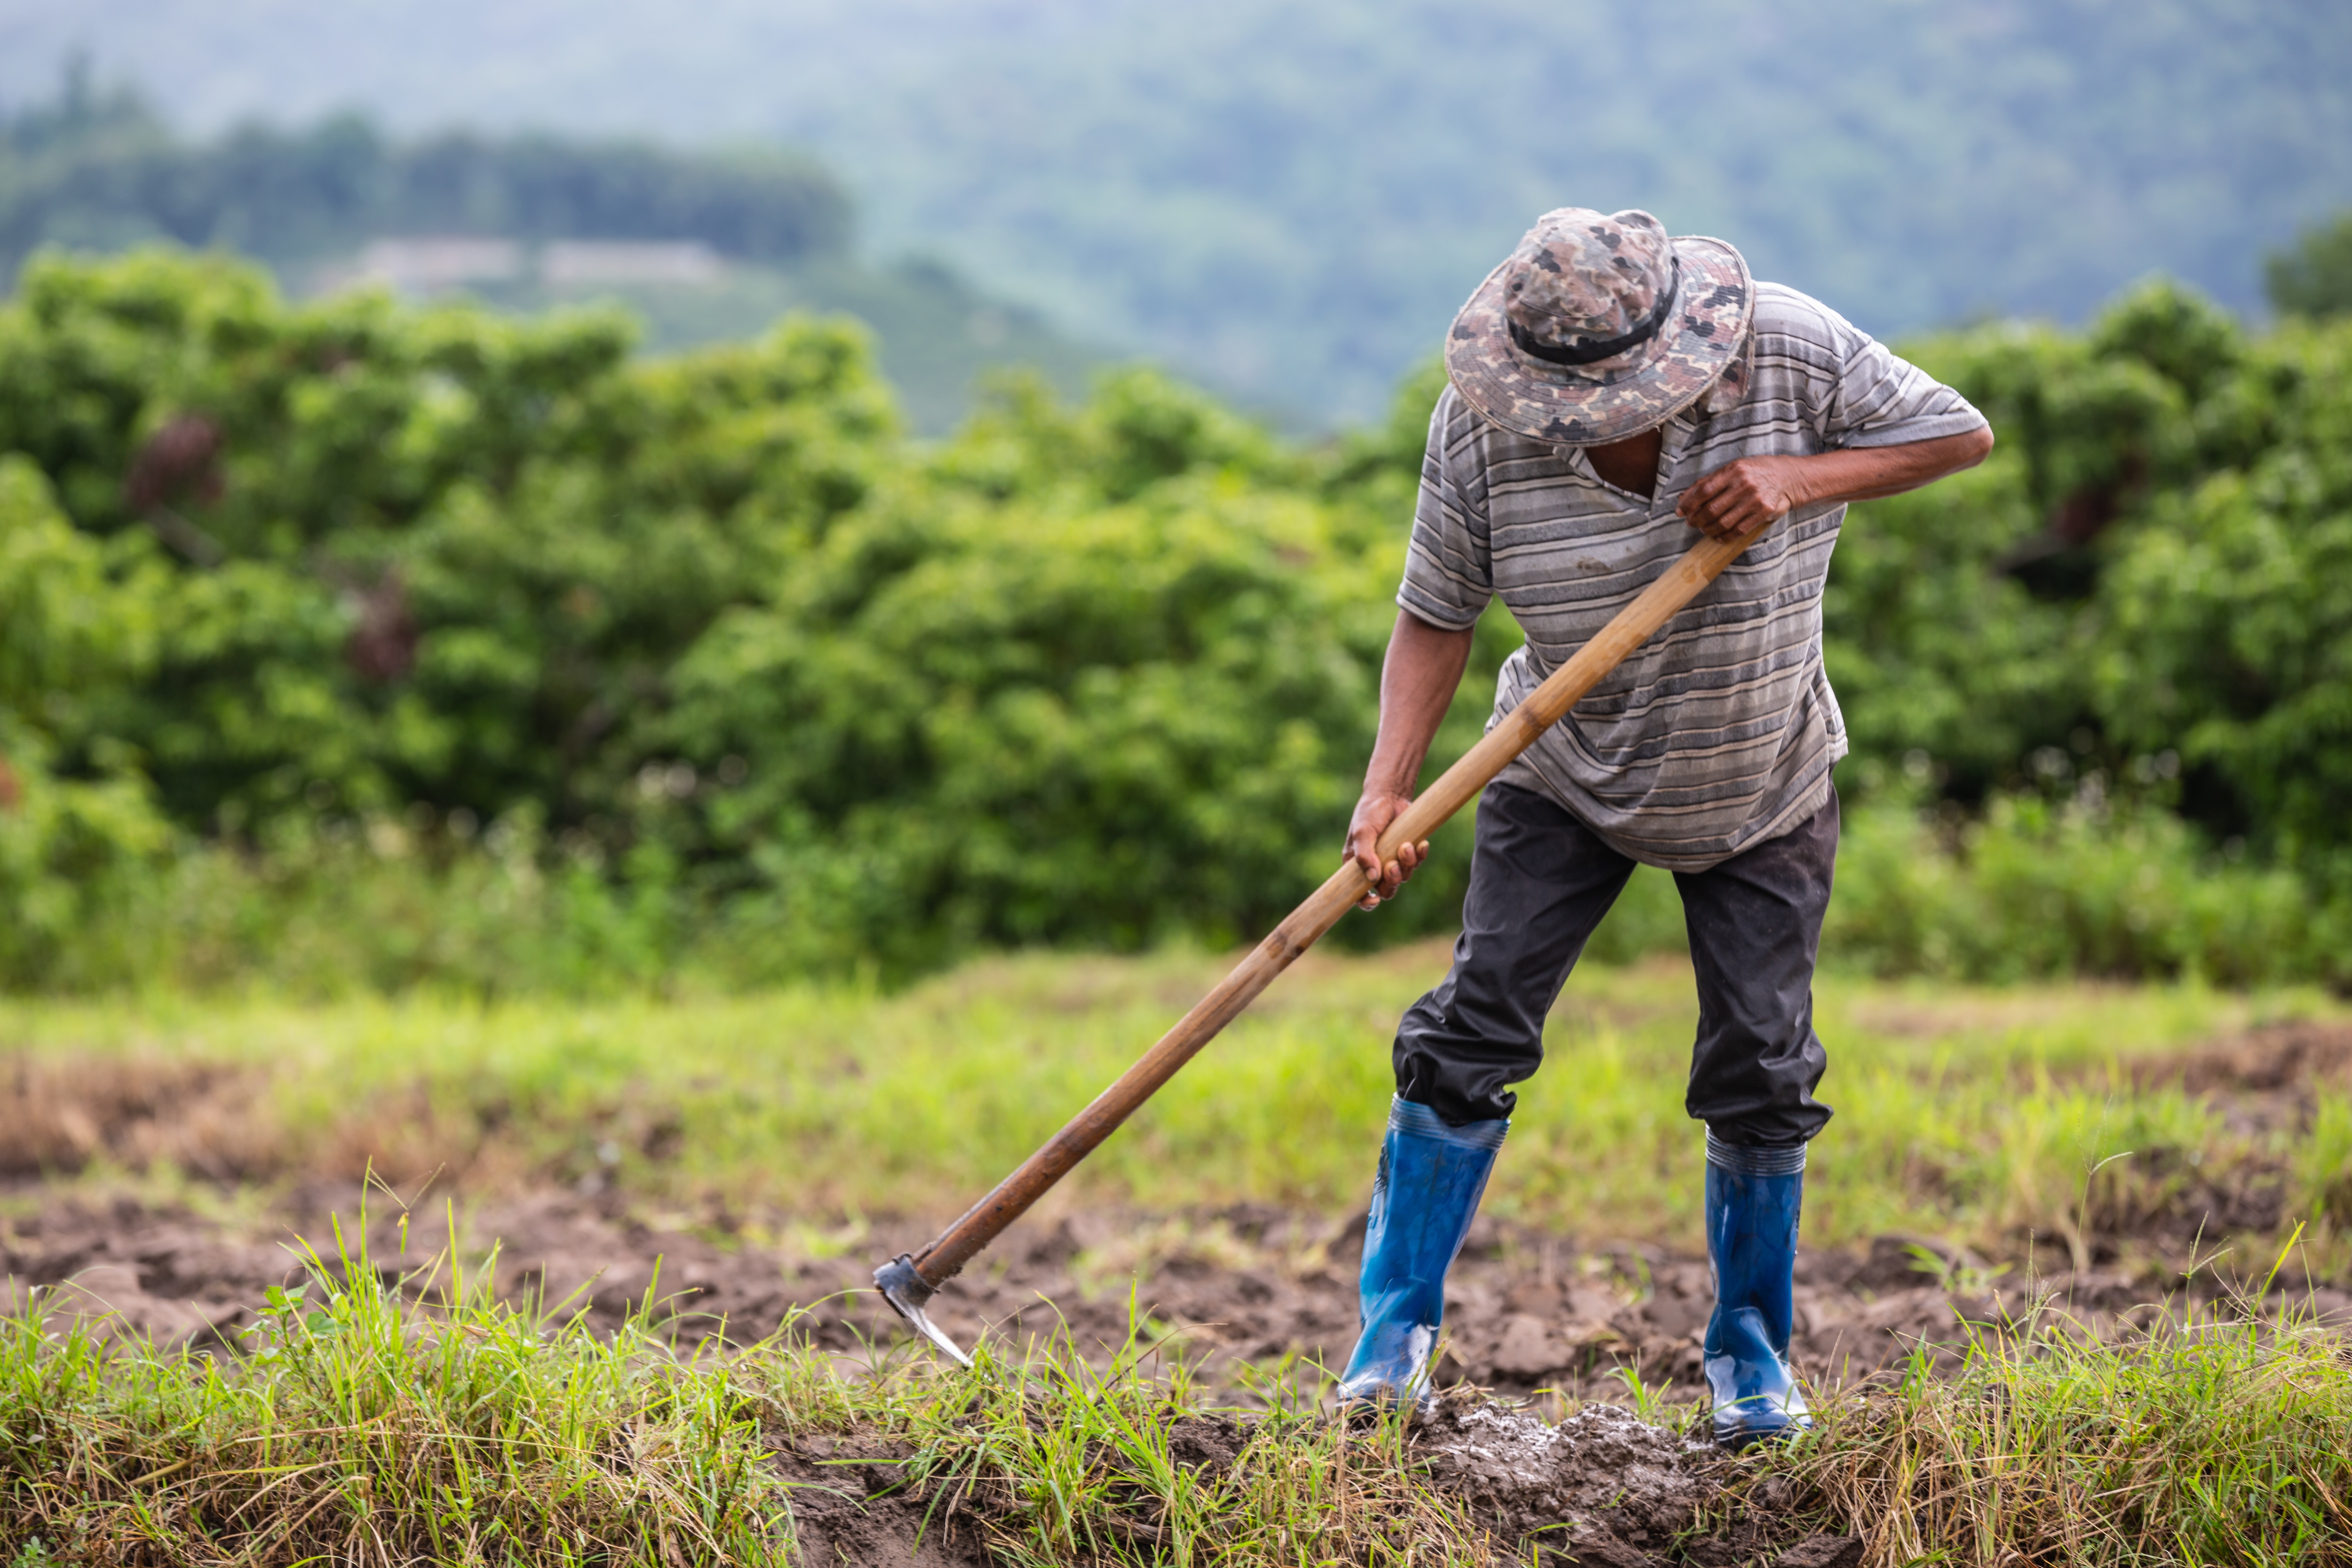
left=0, top=1025, right=2352, bottom=1568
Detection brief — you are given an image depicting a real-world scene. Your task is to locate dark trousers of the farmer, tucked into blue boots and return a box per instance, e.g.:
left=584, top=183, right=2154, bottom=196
left=1397, top=783, right=1837, bottom=1145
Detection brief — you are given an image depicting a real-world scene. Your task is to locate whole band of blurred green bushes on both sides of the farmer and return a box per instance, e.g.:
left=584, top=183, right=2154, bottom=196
left=0, top=252, right=2352, bottom=985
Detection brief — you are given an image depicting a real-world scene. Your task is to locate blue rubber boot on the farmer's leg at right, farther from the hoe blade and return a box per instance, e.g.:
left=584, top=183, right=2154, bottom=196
left=1703, top=1133, right=1813, bottom=1448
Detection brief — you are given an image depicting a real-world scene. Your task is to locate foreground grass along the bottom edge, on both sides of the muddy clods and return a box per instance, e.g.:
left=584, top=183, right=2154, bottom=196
left=0, top=1225, right=2352, bottom=1568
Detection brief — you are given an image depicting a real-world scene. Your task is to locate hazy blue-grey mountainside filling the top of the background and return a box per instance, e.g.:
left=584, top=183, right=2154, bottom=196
left=0, top=0, right=2352, bottom=423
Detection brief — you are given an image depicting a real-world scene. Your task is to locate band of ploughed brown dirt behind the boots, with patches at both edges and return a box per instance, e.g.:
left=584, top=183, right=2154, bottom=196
left=0, top=1025, right=2352, bottom=1408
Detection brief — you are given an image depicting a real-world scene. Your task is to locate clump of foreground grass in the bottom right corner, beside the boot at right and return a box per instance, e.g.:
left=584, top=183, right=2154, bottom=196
left=1764, top=1260, right=2352, bottom=1568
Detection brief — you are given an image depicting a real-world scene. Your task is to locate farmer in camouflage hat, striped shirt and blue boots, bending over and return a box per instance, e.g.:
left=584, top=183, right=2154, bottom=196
left=1341, top=207, right=1992, bottom=1446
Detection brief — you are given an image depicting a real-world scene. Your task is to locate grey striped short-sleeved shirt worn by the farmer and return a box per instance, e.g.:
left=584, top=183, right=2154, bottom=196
left=1397, top=282, right=1985, bottom=870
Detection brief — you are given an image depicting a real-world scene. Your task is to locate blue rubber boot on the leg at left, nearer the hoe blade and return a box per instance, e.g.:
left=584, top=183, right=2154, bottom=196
left=1338, top=1100, right=1510, bottom=1406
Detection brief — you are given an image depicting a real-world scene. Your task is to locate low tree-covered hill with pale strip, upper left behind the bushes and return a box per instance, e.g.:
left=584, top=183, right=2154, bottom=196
left=0, top=73, right=1101, bottom=432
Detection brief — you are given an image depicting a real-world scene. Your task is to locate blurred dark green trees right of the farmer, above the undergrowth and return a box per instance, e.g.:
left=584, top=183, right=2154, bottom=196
left=1825, top=282, right=2352, bottom=853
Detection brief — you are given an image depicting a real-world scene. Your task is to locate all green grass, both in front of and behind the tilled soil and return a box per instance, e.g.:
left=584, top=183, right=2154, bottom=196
left=0, top=945, right=2352, bottom=1568
